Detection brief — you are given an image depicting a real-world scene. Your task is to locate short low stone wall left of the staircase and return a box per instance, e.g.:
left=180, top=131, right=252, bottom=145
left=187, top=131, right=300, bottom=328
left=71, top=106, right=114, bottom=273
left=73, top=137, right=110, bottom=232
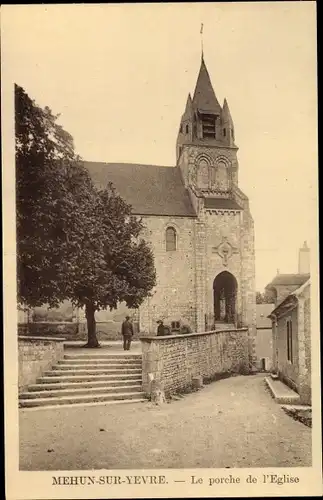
left=18, top=336, right=65, bottom=392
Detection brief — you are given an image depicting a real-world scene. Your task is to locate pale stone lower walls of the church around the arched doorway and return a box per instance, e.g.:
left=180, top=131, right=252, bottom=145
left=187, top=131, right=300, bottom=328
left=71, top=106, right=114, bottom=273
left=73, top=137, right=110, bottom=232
left=139, top=206, right=256, bottom=352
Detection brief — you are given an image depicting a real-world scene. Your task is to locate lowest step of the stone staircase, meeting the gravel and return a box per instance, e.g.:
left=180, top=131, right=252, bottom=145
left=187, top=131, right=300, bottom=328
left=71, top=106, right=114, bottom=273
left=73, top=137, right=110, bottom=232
left=19, top=392, right=144, bottom=408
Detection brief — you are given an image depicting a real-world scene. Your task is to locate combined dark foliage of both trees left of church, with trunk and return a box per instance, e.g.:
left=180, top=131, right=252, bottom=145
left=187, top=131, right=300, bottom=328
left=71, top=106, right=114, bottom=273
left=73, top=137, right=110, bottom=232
left=15, top=85, right=156, bottom=346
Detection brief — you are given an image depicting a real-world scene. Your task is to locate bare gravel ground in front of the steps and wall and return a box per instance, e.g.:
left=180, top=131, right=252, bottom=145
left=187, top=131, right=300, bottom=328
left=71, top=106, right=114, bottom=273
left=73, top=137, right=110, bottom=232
left=19, top=375, right=311, bottom=470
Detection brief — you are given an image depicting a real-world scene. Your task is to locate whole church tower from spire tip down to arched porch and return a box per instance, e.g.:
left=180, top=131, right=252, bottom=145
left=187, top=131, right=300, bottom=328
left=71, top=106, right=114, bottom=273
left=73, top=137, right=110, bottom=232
left=176, top=55, right=255, bottom=331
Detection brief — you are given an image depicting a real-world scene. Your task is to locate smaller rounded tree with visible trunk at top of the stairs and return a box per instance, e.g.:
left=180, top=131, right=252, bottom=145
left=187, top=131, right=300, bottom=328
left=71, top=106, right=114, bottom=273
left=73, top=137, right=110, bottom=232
left=71, top=184, right=156, bottom=347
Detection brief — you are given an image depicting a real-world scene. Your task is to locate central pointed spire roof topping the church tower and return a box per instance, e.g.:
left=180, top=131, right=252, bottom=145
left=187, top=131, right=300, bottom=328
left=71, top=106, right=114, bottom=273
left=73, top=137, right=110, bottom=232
left=193, top=56, right=221, bottom=113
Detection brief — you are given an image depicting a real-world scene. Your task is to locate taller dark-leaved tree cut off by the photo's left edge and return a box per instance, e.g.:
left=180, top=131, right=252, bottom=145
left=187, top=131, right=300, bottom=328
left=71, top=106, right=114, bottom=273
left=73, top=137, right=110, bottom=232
left=15, top=85, right=95, bottom=307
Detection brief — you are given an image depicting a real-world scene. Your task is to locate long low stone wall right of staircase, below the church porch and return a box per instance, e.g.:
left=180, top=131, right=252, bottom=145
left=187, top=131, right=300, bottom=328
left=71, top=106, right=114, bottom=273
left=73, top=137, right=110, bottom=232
left=140, top=328, right=249, bottom=396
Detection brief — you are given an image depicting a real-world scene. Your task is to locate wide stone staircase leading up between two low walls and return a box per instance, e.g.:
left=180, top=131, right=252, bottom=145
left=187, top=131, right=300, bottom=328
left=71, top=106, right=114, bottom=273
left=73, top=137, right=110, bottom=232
left=19, top=353, right=145, bottom=408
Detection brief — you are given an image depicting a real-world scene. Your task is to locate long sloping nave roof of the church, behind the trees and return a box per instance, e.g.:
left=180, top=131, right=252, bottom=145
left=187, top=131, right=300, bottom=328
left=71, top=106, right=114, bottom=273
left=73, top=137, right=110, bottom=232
left=84, top=162, right=196, bottom=217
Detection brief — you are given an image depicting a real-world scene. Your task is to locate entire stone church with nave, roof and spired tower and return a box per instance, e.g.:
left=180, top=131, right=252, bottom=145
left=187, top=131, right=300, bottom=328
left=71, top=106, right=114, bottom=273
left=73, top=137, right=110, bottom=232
left=86, top=55, right=256, bottom=342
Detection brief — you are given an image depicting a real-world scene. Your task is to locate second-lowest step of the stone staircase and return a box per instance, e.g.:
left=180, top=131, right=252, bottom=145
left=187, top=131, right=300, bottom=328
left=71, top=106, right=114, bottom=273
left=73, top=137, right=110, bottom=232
left=19, top=384, right=142, bottom=400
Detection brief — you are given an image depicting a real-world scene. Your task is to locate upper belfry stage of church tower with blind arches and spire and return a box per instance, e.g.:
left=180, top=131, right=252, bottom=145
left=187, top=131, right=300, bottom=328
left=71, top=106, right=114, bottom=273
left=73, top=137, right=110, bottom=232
left=176, top=53, right=238, bottom=196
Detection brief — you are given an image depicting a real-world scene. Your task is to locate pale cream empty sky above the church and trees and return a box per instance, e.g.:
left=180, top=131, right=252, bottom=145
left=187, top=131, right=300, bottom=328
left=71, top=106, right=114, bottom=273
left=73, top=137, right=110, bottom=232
left=1, top=2, right=318, bottom=291
